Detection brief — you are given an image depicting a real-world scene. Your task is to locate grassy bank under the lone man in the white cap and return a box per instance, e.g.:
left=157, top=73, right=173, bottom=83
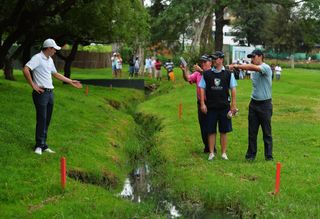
left=0, top=71, right=159, bottom=218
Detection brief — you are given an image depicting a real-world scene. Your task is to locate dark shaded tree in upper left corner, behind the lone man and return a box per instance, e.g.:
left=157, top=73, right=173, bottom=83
left=0, top=0, right=78, bottom=80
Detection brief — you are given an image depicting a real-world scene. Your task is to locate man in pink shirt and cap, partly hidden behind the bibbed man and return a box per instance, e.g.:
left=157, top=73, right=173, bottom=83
left=180, top=55, right=217, bottom=153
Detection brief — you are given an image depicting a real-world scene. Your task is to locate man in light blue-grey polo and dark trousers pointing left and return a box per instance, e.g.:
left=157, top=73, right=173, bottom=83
left=230, top=49, right=273, bottom=161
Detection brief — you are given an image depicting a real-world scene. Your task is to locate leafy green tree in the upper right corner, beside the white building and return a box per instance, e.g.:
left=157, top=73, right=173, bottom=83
left=233, top=0, right=320, bottom=53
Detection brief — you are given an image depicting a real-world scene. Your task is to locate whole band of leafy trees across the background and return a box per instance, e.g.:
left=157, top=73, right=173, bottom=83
left=0, top=0, right=320, bottom=79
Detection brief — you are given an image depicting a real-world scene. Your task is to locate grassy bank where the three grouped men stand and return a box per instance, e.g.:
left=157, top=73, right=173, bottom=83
left=139, top=69, right=320, bottom=218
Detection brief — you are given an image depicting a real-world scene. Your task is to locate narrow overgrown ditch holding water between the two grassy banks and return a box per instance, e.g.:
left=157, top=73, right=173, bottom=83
left=118, top=109, right=234, bottom=219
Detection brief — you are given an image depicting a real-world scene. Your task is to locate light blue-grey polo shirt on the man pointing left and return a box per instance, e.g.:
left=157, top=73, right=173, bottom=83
left=251, top=63, right=272, bottom=100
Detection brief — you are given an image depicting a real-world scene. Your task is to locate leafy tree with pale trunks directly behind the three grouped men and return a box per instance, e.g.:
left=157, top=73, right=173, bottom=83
left=146, top=0, right=239, bottom=52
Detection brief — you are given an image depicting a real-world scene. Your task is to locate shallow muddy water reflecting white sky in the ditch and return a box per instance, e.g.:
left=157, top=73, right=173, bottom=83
left=118, top=114, right=235, bottom=219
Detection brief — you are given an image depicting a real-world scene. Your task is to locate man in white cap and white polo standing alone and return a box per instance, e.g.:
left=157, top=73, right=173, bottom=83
left=22, top=39, right=82, bottom=155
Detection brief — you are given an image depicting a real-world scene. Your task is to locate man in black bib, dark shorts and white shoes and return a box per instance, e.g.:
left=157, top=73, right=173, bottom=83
left=199, top=51, right=237, bottom=160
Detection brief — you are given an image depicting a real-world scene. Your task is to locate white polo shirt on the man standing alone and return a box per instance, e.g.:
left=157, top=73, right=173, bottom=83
left=26, top=51, right=57, bottom=89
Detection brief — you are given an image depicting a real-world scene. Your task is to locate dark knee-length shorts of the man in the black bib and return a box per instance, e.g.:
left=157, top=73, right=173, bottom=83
left=207, top=108, right=232, bottom=134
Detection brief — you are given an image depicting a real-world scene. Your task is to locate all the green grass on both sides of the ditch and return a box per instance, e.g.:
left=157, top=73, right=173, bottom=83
left=0, top=69, right=320, bottom=218
